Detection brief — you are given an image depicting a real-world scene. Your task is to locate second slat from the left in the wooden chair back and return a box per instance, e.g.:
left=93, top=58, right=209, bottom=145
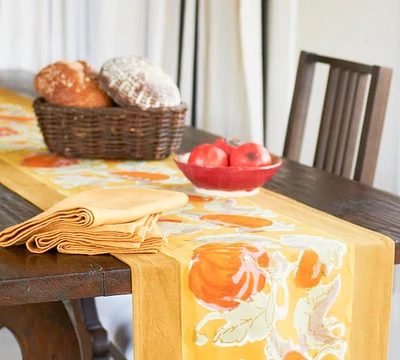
left=324, top=70, right=349, bottom=172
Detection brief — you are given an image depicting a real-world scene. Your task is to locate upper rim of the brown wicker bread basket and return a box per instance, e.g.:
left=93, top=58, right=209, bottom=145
left=33, top=97, right=188, bottom=114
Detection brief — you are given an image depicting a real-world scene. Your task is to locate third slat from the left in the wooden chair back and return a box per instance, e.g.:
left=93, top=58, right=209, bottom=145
left=333, top=71, right=360, bottom=175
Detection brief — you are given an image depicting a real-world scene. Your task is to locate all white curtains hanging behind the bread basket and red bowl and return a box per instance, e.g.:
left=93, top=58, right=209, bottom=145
left=0, top=0, right=263, bottom=143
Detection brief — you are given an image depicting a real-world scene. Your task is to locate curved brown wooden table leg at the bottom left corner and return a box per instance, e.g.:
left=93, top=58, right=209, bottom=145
left=0, top=302, right=84, bottom=360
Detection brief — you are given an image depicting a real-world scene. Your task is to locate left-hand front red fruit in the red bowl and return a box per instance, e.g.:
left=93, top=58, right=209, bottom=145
left=188, top=144, right=229, bottom=167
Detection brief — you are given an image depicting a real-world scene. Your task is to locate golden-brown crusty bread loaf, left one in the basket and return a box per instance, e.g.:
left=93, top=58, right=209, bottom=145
left=34, top=61, right=112, bottom=108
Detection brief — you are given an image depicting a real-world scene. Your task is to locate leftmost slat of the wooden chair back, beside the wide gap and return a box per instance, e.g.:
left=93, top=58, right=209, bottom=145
left=314, top=68, right=340, bottom=169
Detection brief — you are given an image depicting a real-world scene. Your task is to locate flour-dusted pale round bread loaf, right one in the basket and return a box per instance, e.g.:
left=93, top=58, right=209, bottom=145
left=98, top=56, right=181, bottom=109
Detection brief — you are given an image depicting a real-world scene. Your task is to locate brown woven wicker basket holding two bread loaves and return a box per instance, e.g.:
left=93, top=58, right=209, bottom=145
left=33, top=98, right=187, bottom=160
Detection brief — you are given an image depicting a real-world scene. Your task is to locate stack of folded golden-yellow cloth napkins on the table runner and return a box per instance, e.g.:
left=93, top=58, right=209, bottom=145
left=0, top=188, right=188, bottom=255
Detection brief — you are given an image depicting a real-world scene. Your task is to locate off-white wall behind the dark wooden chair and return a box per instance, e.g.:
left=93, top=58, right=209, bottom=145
left=268, top=0, right=400, bottom=193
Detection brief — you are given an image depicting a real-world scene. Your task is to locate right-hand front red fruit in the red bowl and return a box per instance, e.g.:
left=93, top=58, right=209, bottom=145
left=229, top=143, right=272, bottom=167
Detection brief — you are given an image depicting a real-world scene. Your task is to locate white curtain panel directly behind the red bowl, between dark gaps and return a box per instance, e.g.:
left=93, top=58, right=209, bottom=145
left=191, top=0, right=263, bottom=143
